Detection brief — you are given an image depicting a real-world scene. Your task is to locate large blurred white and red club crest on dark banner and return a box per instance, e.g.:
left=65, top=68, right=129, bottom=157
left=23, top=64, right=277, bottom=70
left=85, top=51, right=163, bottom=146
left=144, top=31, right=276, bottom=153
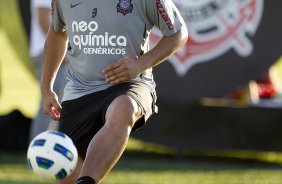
left=151, top=0, right=264, bottom=76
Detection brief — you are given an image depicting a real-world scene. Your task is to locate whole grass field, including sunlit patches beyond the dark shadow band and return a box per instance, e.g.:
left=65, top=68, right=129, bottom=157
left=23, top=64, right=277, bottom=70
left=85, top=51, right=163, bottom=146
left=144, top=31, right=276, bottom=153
left=0, top=138, right=282, bottom=184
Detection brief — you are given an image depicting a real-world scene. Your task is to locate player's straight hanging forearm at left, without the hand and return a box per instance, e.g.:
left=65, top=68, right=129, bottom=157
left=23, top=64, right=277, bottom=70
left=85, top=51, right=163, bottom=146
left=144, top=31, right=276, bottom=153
left=41, top=26, right=67, bottom=93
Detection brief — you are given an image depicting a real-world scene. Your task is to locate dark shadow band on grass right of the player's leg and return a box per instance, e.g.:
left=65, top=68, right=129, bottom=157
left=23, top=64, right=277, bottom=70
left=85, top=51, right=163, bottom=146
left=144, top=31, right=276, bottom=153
left=113, top=153, right=282, bottom=172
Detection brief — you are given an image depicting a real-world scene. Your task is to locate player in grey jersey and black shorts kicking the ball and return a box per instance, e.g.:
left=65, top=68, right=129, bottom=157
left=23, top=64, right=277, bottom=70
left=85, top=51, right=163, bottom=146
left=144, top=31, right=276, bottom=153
left=41, top=0, right=188, bottom=184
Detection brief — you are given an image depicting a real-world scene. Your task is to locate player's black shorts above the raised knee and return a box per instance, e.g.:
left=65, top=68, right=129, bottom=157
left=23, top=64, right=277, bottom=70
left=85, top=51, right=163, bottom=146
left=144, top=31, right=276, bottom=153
left=58, top=82, right=156, bottom=158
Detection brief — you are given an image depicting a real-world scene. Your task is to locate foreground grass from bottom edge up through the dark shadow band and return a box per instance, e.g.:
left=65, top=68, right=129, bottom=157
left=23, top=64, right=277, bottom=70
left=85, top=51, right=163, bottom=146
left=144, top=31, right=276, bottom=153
left=0, top=150, right=282, bottom=184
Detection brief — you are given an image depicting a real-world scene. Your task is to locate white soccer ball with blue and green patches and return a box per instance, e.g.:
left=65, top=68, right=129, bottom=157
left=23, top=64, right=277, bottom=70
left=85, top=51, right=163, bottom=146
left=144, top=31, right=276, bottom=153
left=27, top=131, right=78, bottom=180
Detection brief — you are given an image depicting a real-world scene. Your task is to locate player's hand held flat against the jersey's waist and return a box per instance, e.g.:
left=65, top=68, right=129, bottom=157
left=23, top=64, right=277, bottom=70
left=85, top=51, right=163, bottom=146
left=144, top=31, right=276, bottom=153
left=103, top=57, right=144, bottom=84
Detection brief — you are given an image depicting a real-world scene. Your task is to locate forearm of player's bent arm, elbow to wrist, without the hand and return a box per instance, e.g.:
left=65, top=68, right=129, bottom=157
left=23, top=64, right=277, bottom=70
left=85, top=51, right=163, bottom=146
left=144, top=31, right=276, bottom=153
left=139, top=27, right=188, bottom=69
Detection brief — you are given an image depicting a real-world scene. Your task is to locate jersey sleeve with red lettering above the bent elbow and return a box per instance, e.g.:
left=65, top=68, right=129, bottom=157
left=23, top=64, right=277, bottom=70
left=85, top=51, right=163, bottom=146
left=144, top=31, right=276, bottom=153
left=146, top=0, right=186, bottom=36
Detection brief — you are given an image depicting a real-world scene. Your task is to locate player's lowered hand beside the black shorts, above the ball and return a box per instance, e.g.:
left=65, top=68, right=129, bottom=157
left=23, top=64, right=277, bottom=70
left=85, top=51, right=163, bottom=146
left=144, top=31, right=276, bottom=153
left=42, top=91, right=62, bottom=121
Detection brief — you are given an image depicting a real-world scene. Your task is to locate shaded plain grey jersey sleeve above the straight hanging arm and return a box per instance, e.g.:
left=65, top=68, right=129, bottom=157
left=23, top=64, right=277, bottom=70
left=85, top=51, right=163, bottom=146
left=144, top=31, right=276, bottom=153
left=52, top=0, right=66, bottom=32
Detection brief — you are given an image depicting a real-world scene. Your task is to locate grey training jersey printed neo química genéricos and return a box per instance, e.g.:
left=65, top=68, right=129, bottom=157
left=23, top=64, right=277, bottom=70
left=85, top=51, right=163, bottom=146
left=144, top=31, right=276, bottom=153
left=52, top=0, right=185, bottom=101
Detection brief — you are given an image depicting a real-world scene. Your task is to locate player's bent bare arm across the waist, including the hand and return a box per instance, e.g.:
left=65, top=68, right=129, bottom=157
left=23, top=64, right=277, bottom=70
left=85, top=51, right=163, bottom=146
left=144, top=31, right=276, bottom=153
left=103, top=26, right=188, bottom=84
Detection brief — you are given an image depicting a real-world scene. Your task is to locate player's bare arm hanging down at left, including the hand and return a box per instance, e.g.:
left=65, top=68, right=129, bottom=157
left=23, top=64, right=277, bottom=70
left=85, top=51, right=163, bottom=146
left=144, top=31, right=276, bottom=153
left=40, top=24, right=68, bottom=120
